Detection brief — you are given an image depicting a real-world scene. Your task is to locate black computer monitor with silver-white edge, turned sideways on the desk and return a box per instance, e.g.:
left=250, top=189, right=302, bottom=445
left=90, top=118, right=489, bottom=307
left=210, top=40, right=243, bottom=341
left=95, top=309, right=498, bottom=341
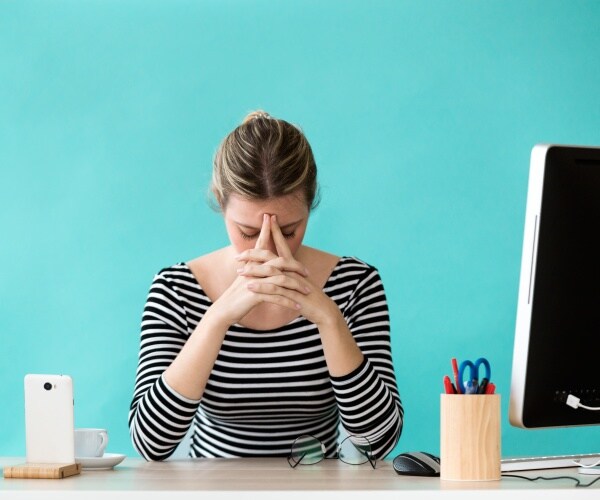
left=509, top=145, right=600, bottom=428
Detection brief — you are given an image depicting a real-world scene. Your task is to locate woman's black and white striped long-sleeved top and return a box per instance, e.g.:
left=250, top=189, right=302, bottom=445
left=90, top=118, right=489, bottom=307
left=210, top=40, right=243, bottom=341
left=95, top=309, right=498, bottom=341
left=129, top=257, right=403, bottom=460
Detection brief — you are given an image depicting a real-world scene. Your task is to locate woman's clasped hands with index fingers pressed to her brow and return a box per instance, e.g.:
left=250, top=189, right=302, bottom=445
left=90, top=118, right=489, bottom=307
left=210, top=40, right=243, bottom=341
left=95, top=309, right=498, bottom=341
left=215, top=214, right=341, bottom=326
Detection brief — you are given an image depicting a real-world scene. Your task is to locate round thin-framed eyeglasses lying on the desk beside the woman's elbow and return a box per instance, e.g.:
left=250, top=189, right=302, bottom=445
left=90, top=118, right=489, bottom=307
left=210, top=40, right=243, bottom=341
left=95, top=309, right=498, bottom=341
left=288, top=434, right=376, bottom=469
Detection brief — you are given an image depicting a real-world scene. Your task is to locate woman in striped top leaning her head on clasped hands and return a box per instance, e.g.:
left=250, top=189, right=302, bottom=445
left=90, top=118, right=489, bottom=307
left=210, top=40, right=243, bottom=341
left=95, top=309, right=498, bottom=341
left=129, top=112, right=403, bottom=460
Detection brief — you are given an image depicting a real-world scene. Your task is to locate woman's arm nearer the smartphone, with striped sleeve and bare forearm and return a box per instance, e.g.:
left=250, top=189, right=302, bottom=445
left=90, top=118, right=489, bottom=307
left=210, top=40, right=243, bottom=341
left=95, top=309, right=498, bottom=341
left=129, top=267, right=258, bottom=460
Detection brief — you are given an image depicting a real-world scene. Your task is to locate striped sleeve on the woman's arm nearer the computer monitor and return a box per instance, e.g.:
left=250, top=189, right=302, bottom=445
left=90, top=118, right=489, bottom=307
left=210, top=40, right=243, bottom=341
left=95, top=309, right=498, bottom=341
left=331, top=266, right=404, bottom=458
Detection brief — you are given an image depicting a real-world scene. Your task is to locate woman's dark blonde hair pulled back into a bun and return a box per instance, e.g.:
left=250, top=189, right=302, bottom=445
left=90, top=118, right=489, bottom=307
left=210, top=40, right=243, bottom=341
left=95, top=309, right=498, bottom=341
left=211, top=111, right=318, bottom=209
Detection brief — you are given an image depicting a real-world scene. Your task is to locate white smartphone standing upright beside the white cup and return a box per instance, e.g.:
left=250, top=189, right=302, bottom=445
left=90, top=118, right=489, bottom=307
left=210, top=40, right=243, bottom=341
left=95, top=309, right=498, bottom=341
left=25, top=374, right=75, bottom=463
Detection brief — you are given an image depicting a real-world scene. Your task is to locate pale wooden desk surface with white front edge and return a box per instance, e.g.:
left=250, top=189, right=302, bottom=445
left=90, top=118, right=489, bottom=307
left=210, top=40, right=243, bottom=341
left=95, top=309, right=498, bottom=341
left=0, top=458, right=600, bottom=500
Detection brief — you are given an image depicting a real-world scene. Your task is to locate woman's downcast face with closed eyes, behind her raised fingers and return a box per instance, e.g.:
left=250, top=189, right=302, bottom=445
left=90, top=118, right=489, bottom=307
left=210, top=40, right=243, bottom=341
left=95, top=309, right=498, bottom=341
left=223, top=193, right=309, bottom=255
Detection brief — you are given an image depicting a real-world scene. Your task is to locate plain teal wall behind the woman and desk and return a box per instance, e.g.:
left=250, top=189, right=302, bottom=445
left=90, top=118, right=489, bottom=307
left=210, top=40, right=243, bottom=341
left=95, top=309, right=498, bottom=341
left=0, top=0, right=600, bottom=455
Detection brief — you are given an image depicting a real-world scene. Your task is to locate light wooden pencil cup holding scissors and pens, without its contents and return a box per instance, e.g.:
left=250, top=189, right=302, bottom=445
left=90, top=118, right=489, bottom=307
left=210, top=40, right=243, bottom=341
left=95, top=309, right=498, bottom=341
left=440, top=394, right=500, bottom=481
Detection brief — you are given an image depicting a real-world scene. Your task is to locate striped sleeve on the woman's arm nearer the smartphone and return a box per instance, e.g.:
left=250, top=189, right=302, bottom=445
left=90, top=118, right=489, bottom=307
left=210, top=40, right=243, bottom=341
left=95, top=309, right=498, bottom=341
left=129, top=273, right=200, bottom=460
